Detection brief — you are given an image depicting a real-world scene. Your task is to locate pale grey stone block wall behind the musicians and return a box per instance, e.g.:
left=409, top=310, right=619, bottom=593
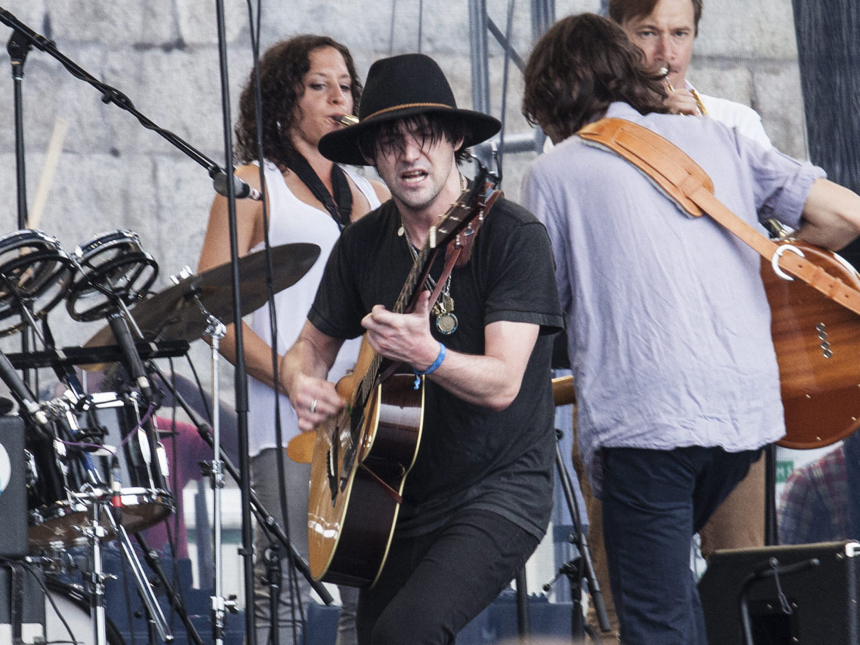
left=0, top=0, right=805, bottom=392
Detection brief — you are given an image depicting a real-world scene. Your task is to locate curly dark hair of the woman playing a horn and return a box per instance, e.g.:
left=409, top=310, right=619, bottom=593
left=234, top=34, right=361, bottom=167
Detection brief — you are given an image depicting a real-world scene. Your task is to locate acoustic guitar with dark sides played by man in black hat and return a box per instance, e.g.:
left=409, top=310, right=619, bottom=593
left=308, top=173, right=499, bottom=587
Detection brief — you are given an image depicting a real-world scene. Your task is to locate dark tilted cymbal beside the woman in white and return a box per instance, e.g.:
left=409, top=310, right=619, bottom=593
left=84, top=243, right=320, bottom=347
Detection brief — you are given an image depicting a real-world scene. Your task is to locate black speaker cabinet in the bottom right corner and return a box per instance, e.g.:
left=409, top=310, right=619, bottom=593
left=699, top=542, right=860, bottom=645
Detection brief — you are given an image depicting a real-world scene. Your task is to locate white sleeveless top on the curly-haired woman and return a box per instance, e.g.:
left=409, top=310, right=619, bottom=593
left=248, top=161, right=380, bottom=457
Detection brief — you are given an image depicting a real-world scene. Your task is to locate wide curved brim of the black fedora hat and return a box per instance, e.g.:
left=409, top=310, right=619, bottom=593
left=318, top=105, right=502, bottom=166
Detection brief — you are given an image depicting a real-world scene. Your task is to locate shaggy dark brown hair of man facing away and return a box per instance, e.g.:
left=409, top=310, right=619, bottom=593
left=522, top=13, right=669, bottom=139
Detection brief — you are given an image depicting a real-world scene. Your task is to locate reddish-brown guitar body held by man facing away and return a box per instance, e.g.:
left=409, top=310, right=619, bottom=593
left=762, top=240, right=860, bottom=449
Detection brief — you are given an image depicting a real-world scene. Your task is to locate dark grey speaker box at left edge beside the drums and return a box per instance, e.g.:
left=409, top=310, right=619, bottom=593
left=0, top=416, right=27, bottom=558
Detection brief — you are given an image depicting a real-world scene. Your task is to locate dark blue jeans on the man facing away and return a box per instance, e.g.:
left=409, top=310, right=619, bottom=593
left=601, top=447, right=761, bottom=645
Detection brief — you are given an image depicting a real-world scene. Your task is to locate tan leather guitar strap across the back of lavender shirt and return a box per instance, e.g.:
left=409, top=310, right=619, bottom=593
left=577, top=119, right=860, bottom=315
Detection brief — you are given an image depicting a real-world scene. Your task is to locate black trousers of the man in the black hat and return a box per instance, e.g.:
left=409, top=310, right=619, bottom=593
left=358, top=510, right=538, bottom=645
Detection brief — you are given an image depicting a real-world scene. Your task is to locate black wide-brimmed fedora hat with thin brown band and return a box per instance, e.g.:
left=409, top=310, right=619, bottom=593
left=319, top=54, right=502, bottom=166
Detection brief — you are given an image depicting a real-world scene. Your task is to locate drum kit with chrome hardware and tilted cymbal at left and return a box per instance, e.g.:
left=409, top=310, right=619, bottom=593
left=0, top=229, right=319, bottom=645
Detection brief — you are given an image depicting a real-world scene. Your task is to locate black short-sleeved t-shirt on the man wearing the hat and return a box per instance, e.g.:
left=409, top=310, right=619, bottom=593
left=308, top=199, right=563, bottom=537
